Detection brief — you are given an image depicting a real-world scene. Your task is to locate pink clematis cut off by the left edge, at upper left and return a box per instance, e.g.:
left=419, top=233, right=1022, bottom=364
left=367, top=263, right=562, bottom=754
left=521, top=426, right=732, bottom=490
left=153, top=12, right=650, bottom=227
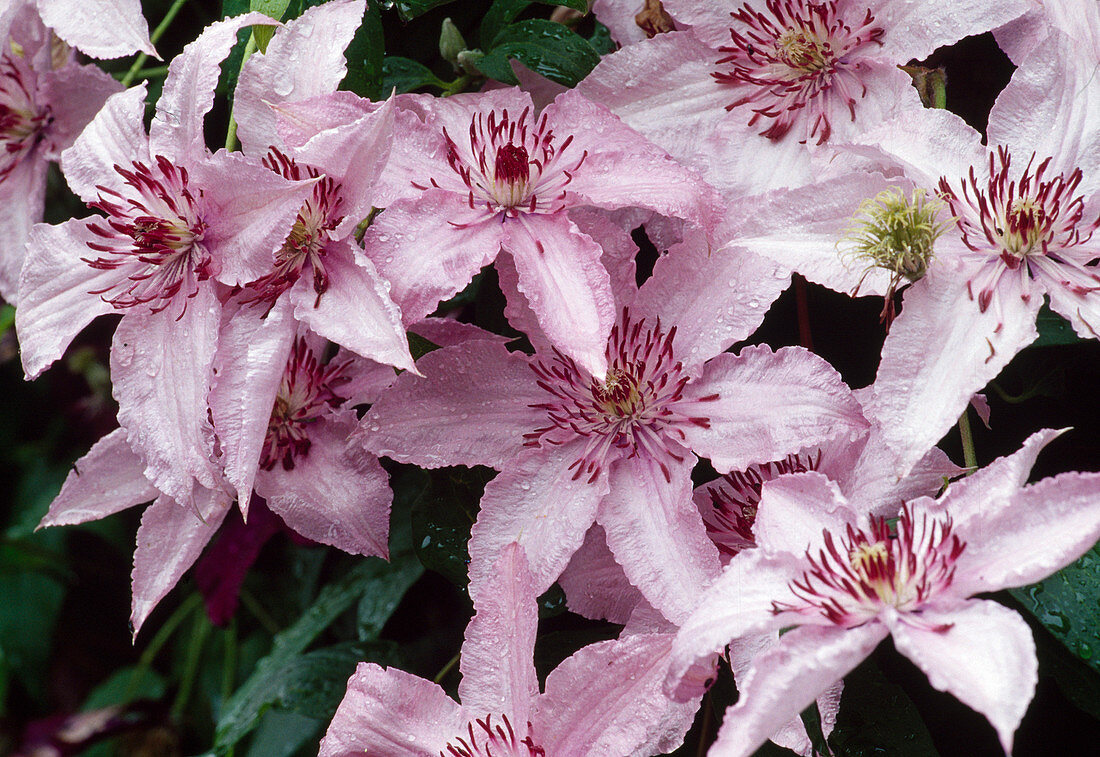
left=0, top=2, right=122, bottom=304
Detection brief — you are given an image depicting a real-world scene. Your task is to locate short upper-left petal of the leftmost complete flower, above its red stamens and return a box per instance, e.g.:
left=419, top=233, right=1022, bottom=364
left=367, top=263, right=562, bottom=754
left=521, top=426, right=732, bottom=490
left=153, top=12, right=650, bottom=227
left=62, top=84, right=150, bottom=202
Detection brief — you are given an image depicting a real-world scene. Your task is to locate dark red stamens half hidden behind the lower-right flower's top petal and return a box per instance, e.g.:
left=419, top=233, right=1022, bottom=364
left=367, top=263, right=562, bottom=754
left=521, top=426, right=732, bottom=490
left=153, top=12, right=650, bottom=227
left=700, top=451, right=822, bottom=557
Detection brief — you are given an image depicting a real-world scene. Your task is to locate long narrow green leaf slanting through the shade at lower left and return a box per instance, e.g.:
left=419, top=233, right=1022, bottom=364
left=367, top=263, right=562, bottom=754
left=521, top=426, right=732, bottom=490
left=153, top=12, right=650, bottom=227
left=215, top=558, right=418, bottom=754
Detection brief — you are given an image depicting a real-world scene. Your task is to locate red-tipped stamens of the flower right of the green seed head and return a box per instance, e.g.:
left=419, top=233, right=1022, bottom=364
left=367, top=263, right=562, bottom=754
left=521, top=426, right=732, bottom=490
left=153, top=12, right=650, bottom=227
left=939, top=146, right=1100, bottom=311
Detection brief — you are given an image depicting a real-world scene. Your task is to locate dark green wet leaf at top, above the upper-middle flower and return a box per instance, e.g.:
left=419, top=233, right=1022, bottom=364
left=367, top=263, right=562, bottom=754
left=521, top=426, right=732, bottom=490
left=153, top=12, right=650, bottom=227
left=476, top=19, right=600, bottom=87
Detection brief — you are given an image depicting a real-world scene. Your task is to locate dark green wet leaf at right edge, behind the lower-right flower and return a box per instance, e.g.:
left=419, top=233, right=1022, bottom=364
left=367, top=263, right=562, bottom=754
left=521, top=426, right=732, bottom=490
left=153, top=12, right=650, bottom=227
left=1010, top=545, right=1100, bottom=670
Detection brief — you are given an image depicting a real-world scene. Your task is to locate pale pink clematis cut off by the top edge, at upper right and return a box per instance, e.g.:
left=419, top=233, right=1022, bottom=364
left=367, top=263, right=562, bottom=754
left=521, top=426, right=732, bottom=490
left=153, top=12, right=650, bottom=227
left=579, top=0, right=1026, bottom=180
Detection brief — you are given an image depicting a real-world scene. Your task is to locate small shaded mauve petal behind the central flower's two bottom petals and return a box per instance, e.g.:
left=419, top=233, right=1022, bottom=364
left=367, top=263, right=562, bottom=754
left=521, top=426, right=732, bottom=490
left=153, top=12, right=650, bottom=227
left=558, top=525, right=642, bottom=624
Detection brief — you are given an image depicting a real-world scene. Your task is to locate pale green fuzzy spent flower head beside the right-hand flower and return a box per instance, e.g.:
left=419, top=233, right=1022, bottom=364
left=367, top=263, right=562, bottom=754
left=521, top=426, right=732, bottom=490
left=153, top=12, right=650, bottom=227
left=844, top=187, right=953, bottom=289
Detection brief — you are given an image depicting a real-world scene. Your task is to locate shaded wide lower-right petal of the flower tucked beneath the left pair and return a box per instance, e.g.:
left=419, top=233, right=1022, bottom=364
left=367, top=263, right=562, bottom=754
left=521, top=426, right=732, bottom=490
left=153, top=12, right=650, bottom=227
left=256, top=409, right=394, bottom=558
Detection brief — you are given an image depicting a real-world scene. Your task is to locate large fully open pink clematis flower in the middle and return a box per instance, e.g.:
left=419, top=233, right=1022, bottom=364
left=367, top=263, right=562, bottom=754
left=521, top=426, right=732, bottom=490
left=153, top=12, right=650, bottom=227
left=362, top=223, right=866, bottom=622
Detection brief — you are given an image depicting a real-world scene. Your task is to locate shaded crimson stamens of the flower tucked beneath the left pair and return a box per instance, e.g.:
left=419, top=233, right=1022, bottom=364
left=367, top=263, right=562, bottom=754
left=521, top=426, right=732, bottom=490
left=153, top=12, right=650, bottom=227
left=260, top=337, right=351, bottom=471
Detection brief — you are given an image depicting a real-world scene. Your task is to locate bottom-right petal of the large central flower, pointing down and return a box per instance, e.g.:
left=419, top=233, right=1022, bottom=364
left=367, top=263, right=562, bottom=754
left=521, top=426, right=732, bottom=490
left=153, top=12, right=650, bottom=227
left=596, top=449, right=721, bottom=623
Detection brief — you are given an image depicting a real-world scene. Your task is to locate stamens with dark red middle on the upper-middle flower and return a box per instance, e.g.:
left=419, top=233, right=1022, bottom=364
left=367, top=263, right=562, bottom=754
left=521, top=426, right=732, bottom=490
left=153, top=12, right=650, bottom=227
left=426, top=108, right=587, bottom=217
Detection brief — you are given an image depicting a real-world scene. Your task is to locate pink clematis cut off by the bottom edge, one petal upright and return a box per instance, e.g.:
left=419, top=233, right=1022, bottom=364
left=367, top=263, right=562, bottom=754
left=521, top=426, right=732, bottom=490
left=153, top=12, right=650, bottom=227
left=320, top=545, right=699, bottom=757
